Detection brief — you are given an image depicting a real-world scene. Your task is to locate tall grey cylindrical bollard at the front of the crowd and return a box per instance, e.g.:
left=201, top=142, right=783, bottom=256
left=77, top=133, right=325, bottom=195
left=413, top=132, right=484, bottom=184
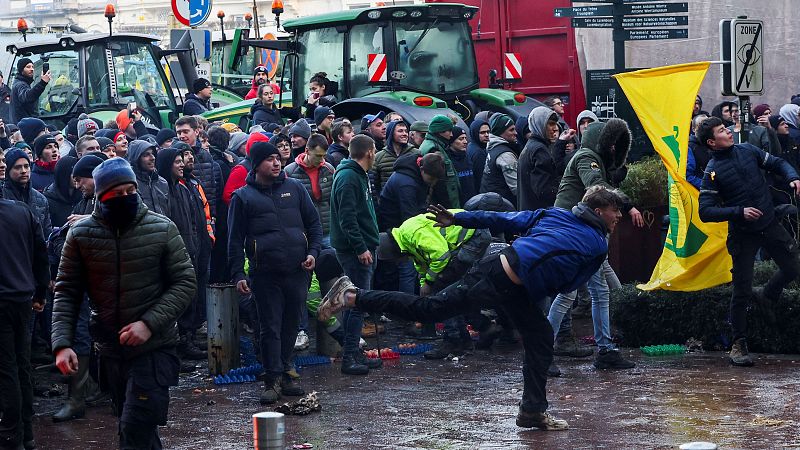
left=206, top=284, right=240, bottom=376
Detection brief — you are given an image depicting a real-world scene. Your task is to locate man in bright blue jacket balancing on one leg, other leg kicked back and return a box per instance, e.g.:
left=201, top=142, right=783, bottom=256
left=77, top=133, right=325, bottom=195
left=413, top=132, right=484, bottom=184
left=318, top=186, right=624, bottom=430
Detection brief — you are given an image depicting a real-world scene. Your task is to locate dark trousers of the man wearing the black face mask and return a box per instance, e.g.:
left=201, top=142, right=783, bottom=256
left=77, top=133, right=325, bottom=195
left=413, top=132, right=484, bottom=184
left=100, top=348, right=180, bottom=450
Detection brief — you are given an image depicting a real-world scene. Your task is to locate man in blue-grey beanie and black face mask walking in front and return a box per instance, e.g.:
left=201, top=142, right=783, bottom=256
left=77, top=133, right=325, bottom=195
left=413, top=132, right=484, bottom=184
left=52, top=158, right=196, bottom=448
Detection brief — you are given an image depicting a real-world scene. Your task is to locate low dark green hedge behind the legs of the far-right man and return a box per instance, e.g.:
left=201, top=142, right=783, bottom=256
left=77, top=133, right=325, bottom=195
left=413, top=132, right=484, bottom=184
left=611, top=263, right=800, bottom=353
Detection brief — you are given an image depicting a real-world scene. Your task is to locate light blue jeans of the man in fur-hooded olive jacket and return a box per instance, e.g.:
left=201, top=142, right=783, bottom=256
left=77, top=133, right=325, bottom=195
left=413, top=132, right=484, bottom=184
left=547, top=259, right=613, bottom=350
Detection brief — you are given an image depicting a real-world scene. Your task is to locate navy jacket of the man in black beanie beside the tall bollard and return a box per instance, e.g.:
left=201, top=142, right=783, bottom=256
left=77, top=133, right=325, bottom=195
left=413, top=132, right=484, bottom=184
left=228, top=172, right=322, bottom=282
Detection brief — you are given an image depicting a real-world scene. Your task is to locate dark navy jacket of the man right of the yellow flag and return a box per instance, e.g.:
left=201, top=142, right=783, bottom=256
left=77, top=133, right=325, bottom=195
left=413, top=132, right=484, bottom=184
left=699, top=144, right=800, bottom=232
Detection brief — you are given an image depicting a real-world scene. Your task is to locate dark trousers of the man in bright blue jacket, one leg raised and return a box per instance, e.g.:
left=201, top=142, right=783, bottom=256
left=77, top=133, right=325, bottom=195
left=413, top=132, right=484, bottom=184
left=356, top=248, right=553, bottom=412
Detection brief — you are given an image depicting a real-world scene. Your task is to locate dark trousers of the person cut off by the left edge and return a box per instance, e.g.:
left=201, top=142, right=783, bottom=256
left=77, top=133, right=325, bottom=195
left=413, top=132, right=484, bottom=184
left=0, top=300, right=33, bottom=448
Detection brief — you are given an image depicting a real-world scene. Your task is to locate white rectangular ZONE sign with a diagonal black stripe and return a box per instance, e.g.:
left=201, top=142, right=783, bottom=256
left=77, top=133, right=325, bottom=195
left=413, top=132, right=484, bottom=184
left=731, top=19, right=764, bottom=96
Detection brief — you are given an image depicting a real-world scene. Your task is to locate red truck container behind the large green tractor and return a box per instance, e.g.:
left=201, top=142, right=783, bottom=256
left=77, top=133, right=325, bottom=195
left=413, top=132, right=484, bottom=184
left=427, top=0, right=586, bottom=127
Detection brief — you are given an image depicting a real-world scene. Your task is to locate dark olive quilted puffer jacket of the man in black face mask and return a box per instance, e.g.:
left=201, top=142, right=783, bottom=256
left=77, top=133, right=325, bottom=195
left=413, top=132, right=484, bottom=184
left=52, top=200, right=197, bottom=360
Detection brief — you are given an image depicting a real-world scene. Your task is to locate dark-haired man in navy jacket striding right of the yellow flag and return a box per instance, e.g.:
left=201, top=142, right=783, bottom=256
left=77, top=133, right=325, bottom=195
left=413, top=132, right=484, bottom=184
left=696, top=117, right=800, bottom=367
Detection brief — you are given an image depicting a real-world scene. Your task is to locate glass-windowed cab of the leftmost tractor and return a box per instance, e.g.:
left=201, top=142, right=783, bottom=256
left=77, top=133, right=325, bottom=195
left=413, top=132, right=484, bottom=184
left=6, top=33, right=178, bottom=127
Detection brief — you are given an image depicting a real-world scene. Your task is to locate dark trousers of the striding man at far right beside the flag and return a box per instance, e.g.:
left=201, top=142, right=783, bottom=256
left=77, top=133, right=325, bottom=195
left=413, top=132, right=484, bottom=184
left=727, top=220, right=800, bottom=340
